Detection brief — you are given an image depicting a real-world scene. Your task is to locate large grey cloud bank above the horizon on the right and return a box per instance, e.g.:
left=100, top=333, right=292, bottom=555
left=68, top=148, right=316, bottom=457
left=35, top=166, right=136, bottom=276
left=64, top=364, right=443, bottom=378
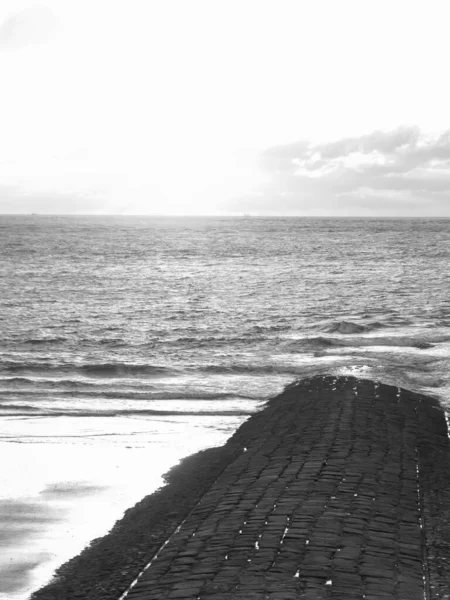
left=228, top=126, right=450, bottom=216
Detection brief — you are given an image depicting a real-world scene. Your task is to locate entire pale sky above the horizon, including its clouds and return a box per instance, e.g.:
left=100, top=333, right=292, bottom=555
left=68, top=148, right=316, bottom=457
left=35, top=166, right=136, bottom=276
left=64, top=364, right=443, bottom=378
left=0, top=0, right=450, bottom=216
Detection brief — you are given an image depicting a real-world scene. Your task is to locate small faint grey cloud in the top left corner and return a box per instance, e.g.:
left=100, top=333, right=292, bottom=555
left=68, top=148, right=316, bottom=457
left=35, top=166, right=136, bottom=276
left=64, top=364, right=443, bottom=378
left=0, top=6, right=58, bottom=49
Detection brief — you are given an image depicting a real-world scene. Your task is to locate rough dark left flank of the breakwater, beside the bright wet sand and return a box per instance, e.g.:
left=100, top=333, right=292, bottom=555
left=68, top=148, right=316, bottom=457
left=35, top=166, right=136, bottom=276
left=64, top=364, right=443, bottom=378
left=30, top=399, right=264, bottom=600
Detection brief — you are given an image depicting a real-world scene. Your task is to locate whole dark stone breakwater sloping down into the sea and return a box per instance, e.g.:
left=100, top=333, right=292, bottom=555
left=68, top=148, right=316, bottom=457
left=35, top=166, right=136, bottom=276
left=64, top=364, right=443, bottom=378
left=32, top=377, right=450, bottom=600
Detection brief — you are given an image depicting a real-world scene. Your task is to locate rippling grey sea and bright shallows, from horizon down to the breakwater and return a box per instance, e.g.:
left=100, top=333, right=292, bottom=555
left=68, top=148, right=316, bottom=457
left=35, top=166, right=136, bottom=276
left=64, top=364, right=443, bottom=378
left=0, top=216, right=450, bottom=600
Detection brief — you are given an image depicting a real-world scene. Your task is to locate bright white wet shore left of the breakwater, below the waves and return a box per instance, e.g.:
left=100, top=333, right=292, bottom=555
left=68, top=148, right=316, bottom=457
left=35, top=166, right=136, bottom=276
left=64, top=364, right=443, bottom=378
left=0, top=417, right=245, bottom=600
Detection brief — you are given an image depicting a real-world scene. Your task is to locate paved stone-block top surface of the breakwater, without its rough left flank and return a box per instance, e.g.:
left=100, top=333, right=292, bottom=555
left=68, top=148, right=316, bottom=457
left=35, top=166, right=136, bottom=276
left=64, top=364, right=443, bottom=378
left=113, top=377, right=450, bottom=600
